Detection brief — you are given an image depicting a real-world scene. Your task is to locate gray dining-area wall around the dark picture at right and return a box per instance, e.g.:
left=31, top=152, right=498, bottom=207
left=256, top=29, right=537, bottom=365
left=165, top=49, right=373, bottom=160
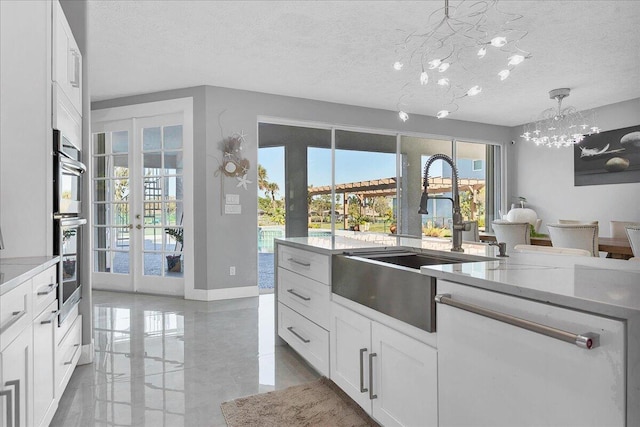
left=509, top=98, right=640, bottom=236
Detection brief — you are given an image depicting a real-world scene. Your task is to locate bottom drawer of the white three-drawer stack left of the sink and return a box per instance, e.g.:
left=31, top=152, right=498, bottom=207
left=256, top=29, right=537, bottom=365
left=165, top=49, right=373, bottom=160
left=278, top=303, right=329, bottom=376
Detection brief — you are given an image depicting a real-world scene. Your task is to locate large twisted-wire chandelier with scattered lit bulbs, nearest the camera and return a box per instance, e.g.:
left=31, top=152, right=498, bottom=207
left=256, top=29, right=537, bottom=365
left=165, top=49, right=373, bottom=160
left=393, top=0, right=531, bottom=121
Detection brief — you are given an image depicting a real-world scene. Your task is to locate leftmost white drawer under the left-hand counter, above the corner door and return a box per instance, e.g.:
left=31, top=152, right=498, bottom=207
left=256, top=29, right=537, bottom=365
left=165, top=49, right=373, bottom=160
left=0, top=280, right=32, bottom=349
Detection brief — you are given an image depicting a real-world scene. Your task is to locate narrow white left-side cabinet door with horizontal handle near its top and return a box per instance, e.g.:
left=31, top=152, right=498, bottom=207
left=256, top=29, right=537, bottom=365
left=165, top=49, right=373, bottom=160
left=33, top=300, right=58, bottom=426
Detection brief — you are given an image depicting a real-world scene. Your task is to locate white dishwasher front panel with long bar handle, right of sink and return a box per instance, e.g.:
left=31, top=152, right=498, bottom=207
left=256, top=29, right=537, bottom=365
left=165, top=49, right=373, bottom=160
left=437, top=280, right=626, bottom=427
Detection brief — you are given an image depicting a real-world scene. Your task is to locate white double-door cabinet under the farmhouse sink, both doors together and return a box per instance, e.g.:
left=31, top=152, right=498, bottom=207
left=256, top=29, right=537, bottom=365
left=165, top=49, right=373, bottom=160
left=330, top=303, right=438, bottom=427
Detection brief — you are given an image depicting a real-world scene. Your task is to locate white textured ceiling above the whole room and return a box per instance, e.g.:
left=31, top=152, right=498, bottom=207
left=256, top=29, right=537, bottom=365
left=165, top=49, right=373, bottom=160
left=88, top=0, right=640, bottom=126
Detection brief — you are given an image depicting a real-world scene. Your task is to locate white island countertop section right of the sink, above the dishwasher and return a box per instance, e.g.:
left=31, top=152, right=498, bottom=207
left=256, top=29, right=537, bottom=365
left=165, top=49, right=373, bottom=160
left=421, top=253, right=640, bottom=319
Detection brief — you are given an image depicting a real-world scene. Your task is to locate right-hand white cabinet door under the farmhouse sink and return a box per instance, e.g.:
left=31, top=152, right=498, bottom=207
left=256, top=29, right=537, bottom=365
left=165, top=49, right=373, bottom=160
left=369, top=322, right=438, bottom=427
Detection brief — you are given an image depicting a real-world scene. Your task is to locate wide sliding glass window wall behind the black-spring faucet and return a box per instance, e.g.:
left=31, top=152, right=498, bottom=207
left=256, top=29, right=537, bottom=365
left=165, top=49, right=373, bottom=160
left=259, top=123, right=502, bottom=242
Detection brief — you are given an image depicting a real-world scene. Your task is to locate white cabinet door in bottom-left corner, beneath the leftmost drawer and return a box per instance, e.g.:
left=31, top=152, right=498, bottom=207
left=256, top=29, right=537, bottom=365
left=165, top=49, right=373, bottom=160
left=0, top=325, right=33, bottom=427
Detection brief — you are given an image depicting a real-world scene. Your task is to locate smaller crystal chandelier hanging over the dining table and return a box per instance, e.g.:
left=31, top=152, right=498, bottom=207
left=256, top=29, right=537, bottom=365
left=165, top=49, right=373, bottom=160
left=520, top=88, right=600, bottom=148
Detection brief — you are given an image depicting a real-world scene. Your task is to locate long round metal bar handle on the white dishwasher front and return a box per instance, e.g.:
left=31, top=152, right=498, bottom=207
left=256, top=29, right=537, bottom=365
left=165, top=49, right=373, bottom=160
left=435, top=294, right=600, bottom=350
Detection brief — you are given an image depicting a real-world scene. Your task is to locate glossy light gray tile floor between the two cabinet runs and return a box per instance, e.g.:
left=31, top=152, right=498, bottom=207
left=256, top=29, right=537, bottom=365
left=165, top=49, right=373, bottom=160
left=51, top=291, right=318, bottom=427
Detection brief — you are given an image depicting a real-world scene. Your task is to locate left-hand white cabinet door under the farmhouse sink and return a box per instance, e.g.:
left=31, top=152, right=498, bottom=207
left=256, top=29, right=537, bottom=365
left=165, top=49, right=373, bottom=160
left=329, top=303, right=371, bottom=413
